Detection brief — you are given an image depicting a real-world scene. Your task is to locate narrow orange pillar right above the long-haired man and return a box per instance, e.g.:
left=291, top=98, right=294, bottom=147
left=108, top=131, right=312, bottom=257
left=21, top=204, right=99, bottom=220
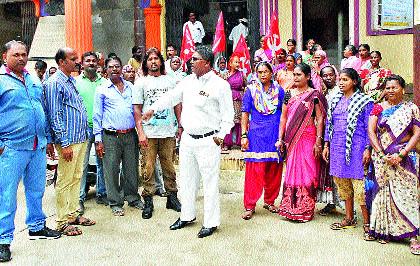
left=144, top=0, right=162, bottom=49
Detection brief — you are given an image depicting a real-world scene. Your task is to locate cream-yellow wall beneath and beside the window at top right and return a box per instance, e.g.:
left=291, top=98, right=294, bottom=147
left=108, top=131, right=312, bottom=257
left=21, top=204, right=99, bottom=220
left=359, top=0, right=418, bottom=83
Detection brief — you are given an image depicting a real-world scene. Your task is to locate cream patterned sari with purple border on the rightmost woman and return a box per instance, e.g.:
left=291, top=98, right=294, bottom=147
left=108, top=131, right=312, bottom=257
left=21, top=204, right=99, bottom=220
left=370, top=102, right=420, bottom=240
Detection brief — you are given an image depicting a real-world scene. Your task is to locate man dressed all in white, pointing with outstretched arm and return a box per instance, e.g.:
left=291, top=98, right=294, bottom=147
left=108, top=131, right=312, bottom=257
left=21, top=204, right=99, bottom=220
left=143, top=46, right=234, bottom=238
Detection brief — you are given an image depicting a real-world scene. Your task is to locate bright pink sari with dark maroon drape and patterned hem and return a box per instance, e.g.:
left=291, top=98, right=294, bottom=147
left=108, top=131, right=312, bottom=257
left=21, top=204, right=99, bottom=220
left=279, top=90, right=327, bottom=222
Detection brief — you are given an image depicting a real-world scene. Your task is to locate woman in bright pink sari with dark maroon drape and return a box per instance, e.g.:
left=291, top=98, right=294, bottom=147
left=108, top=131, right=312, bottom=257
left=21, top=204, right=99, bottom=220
left=276, top=64, right=327, bottom=222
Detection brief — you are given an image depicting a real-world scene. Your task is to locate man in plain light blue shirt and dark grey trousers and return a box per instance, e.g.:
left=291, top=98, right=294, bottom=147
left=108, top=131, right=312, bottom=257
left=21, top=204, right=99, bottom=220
left=93, top=57, right=143, bottom=216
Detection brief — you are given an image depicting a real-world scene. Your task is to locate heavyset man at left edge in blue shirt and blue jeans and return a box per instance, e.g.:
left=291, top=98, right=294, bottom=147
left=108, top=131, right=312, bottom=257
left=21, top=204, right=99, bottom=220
left=0, top=41, right=61, bottom=262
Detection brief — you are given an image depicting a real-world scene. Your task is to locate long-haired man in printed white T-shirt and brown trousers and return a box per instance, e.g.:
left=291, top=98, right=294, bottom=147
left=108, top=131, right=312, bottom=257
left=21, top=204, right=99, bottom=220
left=133, top=48, right=182, bottom=219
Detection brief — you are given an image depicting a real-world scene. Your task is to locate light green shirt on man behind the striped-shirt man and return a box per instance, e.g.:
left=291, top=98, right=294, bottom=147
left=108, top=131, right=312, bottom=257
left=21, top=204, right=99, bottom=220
left=76, top=72, right=106, bottom=127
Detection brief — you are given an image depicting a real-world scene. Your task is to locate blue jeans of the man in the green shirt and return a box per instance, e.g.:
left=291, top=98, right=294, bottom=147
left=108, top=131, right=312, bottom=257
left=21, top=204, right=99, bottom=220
left=79, top=127, right=106, bottom=201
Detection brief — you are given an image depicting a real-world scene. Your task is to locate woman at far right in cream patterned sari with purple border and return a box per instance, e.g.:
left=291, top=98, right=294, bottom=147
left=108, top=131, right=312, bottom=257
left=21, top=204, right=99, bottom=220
left=369, top=75, right=420, bottom=255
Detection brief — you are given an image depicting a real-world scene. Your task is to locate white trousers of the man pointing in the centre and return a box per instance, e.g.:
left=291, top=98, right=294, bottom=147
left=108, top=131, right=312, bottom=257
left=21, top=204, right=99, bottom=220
left=177, top=132, right=220, bottom=228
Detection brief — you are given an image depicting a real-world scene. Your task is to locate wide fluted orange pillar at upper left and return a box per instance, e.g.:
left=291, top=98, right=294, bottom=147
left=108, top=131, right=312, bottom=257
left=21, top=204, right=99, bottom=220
left=64, top=0, right=93, bottom=57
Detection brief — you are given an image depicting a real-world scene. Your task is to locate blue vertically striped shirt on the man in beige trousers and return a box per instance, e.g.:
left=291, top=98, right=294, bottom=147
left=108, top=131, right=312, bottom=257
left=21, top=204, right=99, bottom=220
left=44, top=70, right=88, bottom=147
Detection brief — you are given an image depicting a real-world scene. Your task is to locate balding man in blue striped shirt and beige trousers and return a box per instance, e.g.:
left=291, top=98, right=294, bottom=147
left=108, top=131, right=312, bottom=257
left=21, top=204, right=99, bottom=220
left=44, top=48, right=95, bottom=236
